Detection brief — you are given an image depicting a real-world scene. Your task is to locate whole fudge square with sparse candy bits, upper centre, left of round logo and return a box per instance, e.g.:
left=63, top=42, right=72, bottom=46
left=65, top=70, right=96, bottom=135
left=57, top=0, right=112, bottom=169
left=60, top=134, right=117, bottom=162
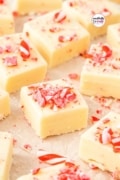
left=23, top=10, right=90, bottom=68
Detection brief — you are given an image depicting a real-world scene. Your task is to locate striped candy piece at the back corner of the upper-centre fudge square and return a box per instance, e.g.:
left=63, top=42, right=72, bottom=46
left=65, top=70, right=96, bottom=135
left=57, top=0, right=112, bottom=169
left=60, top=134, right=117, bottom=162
left=53, top=11, right=67, bottom=23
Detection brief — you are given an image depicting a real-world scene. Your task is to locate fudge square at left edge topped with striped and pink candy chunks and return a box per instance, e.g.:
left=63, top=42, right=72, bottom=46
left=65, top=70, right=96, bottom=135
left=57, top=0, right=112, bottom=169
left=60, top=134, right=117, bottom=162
left=0, top=33, right=47, bottom=93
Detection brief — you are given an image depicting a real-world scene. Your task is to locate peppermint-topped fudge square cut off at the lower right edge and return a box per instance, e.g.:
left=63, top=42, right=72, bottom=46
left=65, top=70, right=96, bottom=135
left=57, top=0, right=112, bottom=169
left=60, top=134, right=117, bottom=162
left=79, top=112, right=120, bottom=172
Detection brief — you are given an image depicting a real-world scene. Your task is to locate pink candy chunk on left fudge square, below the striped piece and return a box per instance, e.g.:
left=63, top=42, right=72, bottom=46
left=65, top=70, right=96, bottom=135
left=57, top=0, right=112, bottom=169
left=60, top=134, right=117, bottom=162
left=4, top=56, right=18, bottom=67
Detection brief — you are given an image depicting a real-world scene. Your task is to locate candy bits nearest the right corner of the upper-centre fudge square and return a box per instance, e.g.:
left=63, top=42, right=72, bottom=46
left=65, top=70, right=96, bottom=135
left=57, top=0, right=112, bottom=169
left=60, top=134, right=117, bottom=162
left=58, top=34, right=77, bottom=42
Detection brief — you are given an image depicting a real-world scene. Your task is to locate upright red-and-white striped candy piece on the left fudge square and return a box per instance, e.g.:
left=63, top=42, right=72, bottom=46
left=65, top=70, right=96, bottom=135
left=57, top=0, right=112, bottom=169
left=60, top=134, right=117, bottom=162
left=19, top=40, right=30, bottom=60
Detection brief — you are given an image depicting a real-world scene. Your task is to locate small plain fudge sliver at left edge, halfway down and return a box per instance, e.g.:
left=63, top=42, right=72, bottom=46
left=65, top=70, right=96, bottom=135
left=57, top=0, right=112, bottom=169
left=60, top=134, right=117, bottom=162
left=0, top=89, right=11, bottom=120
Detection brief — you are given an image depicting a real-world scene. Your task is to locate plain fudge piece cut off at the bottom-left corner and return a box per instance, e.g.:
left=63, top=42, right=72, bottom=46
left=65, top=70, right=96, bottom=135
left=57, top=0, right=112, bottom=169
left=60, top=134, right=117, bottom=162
left=0, top=131, right=13, bottom=180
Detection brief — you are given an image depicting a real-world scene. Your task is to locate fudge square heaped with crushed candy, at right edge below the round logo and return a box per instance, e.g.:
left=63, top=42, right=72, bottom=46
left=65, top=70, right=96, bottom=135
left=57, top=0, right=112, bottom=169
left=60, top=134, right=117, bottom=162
left=80, top=43, right=120, bottom=99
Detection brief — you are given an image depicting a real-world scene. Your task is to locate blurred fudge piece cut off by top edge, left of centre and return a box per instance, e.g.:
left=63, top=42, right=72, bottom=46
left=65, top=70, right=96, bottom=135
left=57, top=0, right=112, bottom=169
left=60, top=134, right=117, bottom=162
left=10, top=0, right=62, bottom=14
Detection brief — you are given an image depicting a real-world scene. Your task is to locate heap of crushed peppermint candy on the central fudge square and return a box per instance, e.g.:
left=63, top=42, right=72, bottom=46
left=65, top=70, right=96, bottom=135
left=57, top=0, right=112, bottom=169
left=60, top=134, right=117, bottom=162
left=29, top=84, right=76, bottom=110
